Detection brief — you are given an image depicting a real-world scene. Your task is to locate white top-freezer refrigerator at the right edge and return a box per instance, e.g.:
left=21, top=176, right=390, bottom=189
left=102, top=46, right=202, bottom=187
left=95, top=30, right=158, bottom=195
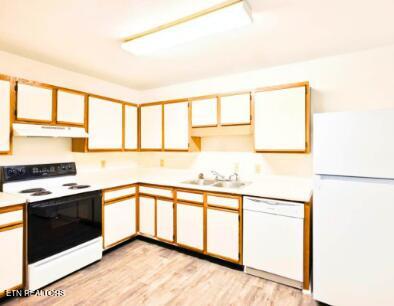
left=312, top=109, right=394, bottom=306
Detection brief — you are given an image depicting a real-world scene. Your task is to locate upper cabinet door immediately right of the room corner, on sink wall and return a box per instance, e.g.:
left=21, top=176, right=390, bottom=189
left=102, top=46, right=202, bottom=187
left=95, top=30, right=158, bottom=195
left=141, top=105, right=163, bottom=150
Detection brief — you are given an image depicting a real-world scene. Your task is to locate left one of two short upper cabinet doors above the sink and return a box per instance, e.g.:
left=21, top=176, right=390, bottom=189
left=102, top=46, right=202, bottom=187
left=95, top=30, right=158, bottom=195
left=192, top=98, right=218, bottom=127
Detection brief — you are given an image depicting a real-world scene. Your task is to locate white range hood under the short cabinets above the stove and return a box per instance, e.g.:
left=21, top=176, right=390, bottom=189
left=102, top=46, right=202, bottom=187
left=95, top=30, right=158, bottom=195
left=12, top=123, right=88, bottom=138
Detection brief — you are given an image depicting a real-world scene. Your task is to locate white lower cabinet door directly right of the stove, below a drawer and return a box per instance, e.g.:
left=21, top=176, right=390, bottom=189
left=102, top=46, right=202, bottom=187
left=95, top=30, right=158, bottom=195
left=104, top=198, right=136, bottom=248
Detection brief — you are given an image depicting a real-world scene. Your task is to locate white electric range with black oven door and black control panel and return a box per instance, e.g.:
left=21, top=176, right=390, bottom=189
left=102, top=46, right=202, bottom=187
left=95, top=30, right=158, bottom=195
left=0, top=163, right=103, bottom=290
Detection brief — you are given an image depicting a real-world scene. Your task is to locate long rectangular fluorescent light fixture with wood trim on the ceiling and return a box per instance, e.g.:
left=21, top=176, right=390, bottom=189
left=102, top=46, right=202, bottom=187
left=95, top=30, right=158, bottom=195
left=122, top=0, right=252, bottom=55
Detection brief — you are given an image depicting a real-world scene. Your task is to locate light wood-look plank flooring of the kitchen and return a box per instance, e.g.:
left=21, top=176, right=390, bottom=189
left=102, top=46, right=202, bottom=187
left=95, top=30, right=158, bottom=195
left=5, top=240, right=317, bottom=306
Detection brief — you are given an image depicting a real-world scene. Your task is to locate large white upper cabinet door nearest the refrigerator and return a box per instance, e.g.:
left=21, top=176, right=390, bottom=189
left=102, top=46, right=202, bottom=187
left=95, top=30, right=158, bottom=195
left=254, top=86, right=306, bottom=151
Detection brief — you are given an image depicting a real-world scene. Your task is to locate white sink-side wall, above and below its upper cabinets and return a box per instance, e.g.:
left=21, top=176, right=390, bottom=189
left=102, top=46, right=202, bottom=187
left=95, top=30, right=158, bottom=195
left=137, top=45, right=394, bottom=177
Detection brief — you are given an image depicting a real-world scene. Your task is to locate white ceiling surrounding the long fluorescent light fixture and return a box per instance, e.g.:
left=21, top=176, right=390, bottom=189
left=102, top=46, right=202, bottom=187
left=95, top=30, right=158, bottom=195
left=0, top=0, right=394, bottom=89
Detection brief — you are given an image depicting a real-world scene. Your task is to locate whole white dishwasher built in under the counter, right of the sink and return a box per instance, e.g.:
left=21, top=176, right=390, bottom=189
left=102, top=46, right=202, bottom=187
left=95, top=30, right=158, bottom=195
left=243, top=197, right=304, bottom=288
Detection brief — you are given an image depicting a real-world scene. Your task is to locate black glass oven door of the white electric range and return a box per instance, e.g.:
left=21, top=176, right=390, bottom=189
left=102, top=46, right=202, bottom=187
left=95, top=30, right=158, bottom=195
left=28, top=191, right=102, bottom=264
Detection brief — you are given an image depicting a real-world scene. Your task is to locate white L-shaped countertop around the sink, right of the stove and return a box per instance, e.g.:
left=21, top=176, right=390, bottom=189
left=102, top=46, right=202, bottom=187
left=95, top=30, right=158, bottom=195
left=78, top=168, right=312, bottom=202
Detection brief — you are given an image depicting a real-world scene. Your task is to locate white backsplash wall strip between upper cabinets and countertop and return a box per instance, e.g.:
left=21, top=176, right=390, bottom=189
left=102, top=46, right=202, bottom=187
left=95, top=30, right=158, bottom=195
left=0, top=136, right=312, bottom=179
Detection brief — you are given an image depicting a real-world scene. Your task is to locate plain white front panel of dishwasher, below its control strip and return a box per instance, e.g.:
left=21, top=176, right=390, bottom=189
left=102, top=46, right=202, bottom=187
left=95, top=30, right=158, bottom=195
left=244, top=210, right=304, bottom=282
